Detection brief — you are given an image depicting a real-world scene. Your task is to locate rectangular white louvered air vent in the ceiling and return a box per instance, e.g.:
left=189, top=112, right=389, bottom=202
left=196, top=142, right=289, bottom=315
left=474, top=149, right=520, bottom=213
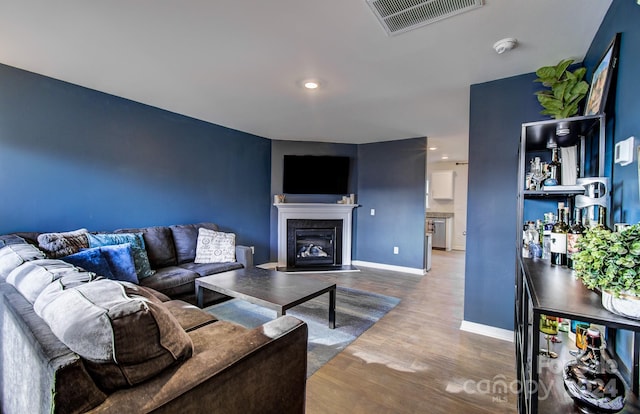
left=366, top=0, right=482, bottom=35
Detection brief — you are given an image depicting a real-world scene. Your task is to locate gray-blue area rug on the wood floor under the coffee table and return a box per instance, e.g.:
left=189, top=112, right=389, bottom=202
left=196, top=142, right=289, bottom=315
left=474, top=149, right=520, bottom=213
left=205, top=286, right=400, bottom=378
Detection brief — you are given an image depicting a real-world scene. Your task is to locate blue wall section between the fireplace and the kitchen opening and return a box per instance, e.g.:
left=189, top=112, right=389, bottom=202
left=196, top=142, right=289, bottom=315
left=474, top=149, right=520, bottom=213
left=355, top=138, right=427, bottom=269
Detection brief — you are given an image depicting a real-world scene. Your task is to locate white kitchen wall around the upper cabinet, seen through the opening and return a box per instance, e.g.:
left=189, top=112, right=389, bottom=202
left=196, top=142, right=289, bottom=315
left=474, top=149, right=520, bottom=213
left=427, top=162, right=468, bottom=250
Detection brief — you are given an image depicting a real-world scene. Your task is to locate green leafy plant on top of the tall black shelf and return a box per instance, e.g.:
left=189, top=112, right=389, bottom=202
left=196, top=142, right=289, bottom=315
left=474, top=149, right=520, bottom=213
left=534, top=59, right=589, bottom=119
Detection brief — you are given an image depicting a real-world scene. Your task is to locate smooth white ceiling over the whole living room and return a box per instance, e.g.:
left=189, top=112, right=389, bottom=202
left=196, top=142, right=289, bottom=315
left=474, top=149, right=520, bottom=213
left=0, top=0, right=611, bottom=161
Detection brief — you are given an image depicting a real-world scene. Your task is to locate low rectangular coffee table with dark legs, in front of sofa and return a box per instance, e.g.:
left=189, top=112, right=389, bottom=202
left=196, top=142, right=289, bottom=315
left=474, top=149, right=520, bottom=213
left=196, top=267, right=336, bottom=329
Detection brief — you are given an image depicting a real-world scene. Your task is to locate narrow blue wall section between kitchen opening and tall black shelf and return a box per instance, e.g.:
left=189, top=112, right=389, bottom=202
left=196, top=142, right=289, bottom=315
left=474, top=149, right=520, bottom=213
left=464, top=74, right=544, bottom=330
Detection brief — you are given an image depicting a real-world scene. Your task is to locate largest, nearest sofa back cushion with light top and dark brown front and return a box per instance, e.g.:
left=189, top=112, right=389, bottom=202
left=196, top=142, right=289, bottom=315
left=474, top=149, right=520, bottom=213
left=34, top=279, right=193, bottom=391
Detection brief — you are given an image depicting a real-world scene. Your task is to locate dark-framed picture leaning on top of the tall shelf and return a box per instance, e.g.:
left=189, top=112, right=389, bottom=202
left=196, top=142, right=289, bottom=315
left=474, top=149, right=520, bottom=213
left=584, top=33, right=620, bottom=116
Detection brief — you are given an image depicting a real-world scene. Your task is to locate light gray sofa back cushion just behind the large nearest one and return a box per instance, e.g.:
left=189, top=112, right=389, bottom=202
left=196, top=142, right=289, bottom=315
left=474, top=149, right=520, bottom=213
left=7, top=259, right=86, bottom=303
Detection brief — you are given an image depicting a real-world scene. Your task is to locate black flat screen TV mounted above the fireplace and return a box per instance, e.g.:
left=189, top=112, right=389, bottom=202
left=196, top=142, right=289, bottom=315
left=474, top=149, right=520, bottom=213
left=282, top=155, right=349, bottom=194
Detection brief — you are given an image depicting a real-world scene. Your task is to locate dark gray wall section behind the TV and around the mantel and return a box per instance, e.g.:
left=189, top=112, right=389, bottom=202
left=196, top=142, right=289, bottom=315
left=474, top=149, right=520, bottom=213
left=271, top=140, right=358, bottom=262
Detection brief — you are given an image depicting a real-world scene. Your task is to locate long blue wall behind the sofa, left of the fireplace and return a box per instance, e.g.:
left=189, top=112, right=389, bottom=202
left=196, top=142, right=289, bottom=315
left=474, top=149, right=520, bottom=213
left=0, top=64, right=272, bottom=263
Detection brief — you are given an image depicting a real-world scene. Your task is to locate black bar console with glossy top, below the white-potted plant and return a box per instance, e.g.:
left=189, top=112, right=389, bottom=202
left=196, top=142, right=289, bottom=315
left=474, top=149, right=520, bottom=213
left=516, top=258, right=640, bottom=414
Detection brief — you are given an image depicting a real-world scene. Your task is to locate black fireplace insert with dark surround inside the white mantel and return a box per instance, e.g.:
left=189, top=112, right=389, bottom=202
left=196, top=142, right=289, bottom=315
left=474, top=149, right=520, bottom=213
left=287, top=219, right=343, bottom=268
